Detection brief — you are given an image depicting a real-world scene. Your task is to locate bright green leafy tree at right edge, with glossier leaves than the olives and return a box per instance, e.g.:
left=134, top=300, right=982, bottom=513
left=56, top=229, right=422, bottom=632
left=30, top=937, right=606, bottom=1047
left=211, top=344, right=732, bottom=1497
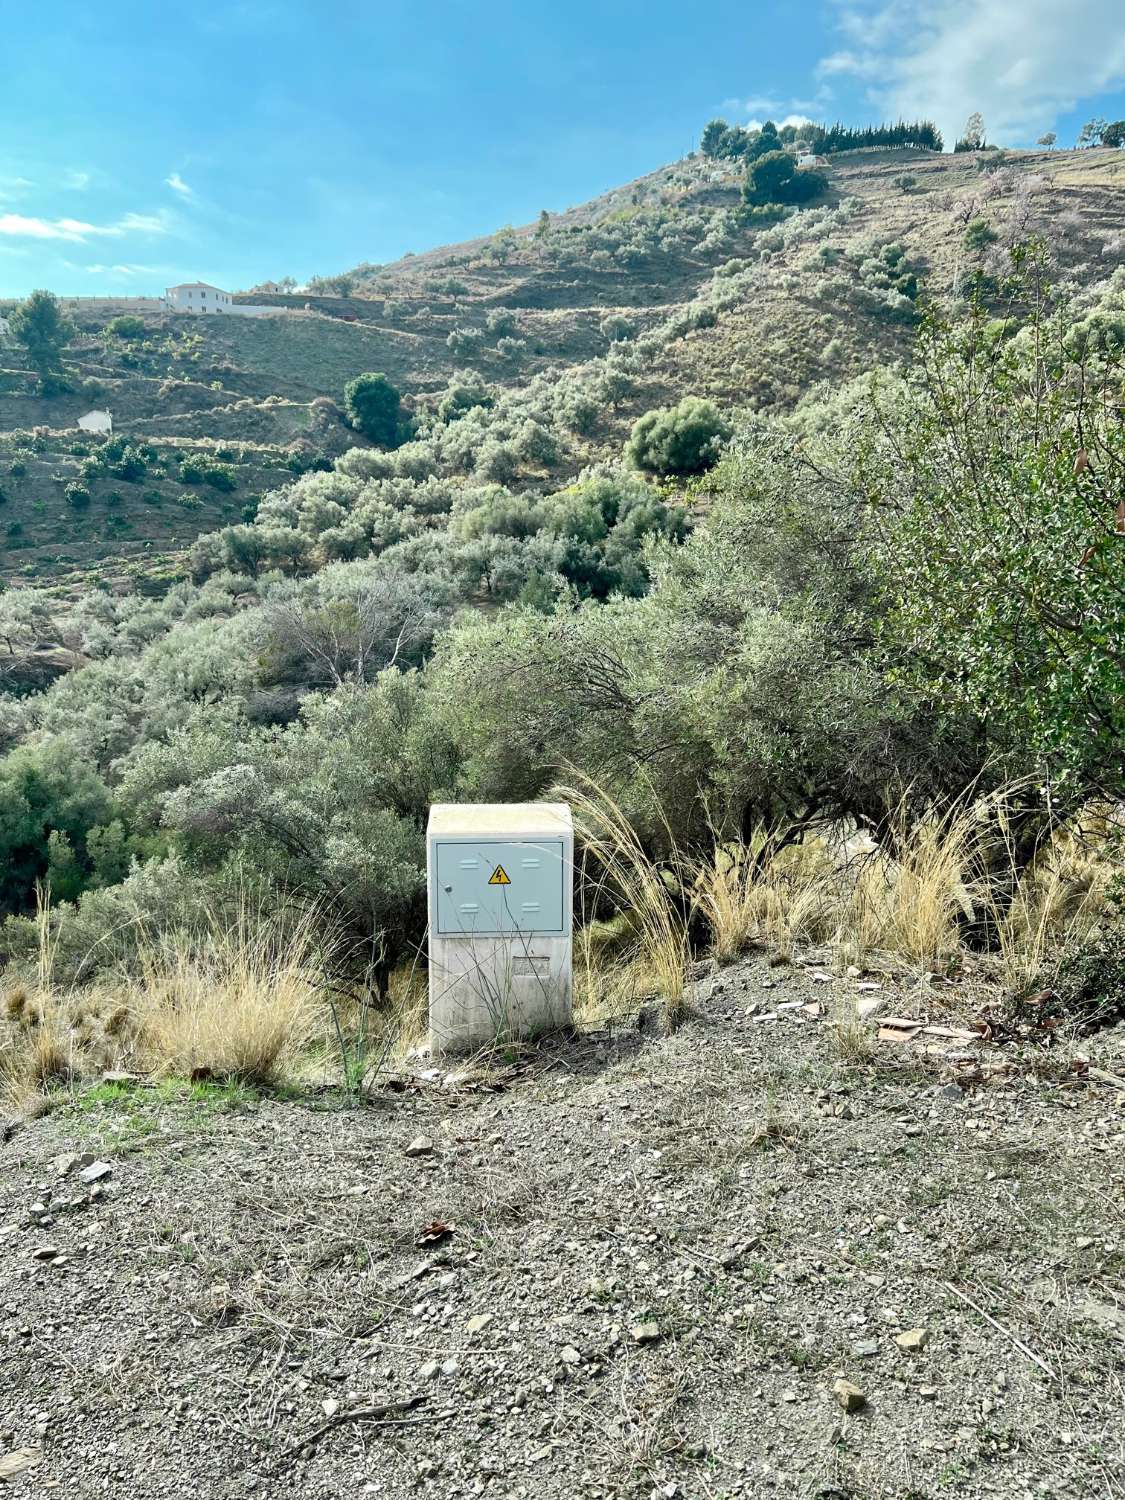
left=857, top=248, right=1125, bottom=798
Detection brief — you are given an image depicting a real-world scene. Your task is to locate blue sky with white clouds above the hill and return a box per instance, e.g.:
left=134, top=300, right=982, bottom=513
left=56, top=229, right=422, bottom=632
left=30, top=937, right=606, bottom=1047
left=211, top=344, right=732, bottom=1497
left=0, top=0, right=1125, bottom=296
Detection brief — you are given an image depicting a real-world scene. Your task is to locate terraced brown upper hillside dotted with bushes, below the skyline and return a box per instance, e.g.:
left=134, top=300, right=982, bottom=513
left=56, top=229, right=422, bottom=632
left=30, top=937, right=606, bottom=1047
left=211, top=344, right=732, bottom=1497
left=0, top=141, right=1125, bottom=590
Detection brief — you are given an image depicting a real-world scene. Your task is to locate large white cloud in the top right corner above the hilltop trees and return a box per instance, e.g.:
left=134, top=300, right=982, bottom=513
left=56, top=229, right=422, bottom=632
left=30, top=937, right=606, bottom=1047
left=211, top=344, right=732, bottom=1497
left=818, top=0, right=1125, bottom=146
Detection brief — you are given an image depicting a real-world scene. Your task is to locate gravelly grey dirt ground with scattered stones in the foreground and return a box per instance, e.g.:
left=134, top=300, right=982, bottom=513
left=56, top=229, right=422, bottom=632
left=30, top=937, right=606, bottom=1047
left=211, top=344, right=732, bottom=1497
left=0, top=959, right=1125, bottom=1500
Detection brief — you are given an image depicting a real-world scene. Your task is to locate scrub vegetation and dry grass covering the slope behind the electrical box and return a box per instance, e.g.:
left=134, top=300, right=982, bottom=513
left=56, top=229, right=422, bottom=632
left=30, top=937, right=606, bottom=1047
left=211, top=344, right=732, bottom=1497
left=0, top=126, right=1125, bottom=1104
